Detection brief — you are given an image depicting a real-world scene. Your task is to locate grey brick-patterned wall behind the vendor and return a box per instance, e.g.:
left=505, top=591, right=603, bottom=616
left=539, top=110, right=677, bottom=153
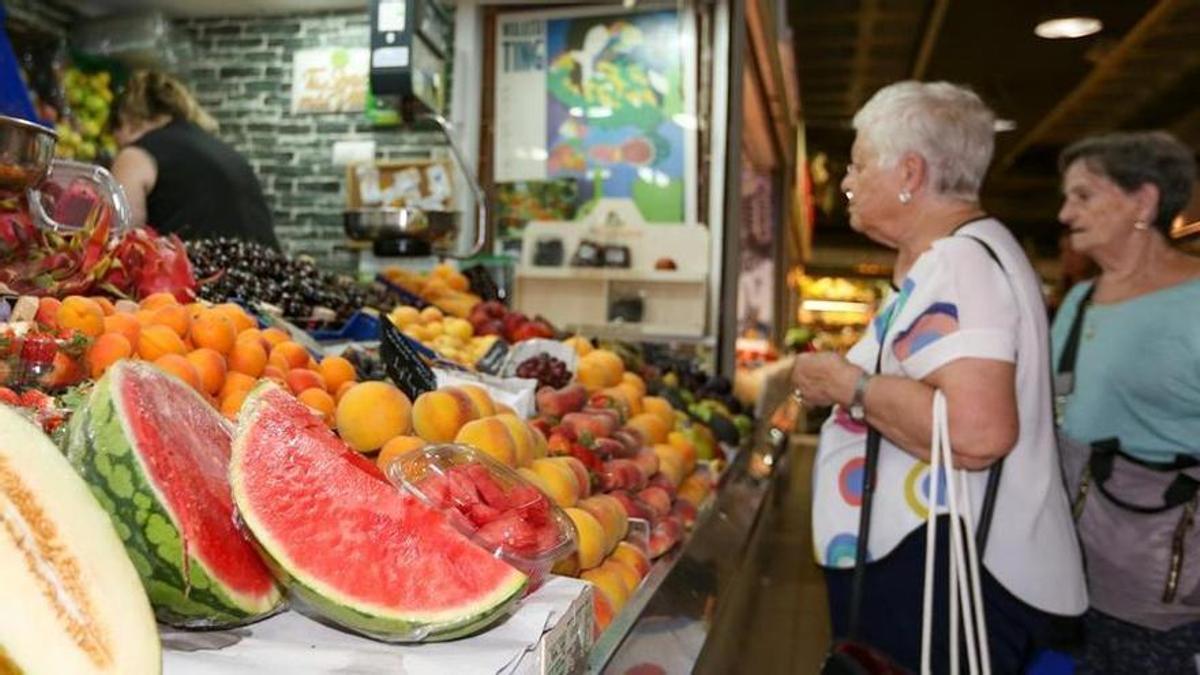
left=176, top=12, right=442, bottom=263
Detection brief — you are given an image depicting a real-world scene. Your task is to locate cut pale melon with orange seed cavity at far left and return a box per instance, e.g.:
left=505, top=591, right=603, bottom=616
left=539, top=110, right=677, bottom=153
left=0, top=406, right=162, bottom=675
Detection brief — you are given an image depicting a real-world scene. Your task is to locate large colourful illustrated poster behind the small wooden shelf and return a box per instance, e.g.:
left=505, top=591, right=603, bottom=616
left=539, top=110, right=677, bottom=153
left=494, top=10, right=695, bottom=222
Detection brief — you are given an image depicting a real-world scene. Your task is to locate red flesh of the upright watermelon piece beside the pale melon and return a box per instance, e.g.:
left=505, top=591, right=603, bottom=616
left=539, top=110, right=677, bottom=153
left=114, top=364, right=275, bottom=605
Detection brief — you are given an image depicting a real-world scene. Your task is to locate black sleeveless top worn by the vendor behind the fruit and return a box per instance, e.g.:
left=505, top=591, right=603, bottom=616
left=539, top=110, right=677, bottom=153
left=133, top=120, right=280, bottom=249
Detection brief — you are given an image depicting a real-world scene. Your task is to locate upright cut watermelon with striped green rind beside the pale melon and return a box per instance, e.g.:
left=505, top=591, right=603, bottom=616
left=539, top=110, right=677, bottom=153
left=67, top=360, right=283, bottom=627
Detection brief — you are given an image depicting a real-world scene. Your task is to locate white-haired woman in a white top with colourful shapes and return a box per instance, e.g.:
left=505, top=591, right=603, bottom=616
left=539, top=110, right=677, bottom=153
left=793, top=82, right=1087, bottom=673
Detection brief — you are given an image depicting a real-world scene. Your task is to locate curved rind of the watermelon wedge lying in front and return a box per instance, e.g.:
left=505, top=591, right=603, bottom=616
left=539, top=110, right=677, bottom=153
left=229, top=383, right=528, bottom=643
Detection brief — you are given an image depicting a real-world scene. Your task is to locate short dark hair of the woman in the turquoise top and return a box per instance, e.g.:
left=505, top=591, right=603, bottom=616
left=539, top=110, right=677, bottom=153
left=1058, top=131, right=1196, bottom=234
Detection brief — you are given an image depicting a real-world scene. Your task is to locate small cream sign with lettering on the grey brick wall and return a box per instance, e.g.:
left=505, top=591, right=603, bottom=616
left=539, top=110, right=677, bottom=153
left=292, top=47, right=371, bottom=113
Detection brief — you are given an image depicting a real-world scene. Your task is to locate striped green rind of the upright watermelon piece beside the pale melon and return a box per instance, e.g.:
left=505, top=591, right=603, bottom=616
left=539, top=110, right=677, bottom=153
left=67, top=362, right=283, bottom=628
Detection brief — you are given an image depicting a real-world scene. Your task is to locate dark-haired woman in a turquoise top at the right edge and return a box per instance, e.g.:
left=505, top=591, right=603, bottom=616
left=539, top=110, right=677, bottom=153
left=1051, top=132, right=1200, bottom=674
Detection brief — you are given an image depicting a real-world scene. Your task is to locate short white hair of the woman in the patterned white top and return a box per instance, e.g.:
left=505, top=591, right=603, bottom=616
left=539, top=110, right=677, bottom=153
left=853, top=80, right=996, bottom=199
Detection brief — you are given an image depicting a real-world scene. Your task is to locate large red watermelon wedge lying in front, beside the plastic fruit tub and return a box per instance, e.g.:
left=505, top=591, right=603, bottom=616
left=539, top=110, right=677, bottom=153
left=229, top=384, right=528, bottom=641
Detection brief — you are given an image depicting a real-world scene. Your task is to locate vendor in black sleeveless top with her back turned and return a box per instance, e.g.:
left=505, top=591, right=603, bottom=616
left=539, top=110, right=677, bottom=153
left=113, top=71, right=280, bottom=249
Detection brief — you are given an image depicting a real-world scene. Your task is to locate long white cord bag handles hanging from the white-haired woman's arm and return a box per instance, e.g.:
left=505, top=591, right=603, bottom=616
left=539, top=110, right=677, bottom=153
left=920, top=390, right=991, bottom=675
